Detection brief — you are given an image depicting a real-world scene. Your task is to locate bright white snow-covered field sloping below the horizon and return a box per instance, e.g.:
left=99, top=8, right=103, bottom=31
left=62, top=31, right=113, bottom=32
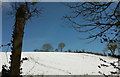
left=0, top=52, right=117, bottom=75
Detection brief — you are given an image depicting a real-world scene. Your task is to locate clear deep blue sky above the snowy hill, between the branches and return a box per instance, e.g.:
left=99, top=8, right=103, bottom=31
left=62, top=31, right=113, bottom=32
left=2, top=2, right=105, bottom=52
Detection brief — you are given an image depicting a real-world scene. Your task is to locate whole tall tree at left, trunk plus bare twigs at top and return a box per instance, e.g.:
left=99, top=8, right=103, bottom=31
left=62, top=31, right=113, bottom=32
left=6, top=2, right=41, bottom=77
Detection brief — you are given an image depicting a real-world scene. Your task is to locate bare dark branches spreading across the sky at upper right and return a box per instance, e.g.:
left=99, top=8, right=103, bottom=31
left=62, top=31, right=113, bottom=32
left=64, top=1, right=120, bottom=74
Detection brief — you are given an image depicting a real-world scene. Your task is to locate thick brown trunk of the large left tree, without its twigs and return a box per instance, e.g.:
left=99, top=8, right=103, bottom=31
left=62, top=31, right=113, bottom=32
left=9, top=6, right=26, bottom=77
